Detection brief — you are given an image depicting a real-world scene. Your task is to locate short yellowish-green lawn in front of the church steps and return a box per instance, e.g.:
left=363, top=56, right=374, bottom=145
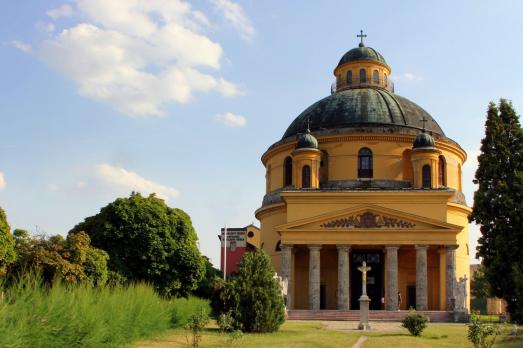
left=135, top=321, right=523, bottom=348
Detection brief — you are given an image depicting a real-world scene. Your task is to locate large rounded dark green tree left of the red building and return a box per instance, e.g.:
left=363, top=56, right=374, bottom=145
left=69, top=193, right=205, bottom=296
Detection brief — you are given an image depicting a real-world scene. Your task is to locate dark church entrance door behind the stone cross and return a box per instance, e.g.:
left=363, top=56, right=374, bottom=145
left=350, top=250, right=384, bottom=310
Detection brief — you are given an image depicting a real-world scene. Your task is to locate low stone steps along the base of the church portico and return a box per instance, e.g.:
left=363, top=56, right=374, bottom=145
left=287, top=309, right=454, bottom=322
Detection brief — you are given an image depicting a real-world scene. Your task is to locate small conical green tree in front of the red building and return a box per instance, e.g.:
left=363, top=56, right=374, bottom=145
left=222, top=249, right=285, bottom=332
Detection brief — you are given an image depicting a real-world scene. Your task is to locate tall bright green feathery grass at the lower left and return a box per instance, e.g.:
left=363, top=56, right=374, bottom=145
left=0, top=275, right=208, bottom=348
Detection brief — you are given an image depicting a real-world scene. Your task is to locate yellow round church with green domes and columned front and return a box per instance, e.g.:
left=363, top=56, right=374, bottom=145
left=256, top=38, right=471, bottom=311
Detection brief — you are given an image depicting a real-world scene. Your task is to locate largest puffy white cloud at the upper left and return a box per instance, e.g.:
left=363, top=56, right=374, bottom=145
left=39, top=0, right=242, bottom=116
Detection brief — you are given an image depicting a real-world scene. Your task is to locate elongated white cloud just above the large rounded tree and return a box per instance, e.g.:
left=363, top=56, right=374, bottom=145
left=95, top=163, right=179, bottom=200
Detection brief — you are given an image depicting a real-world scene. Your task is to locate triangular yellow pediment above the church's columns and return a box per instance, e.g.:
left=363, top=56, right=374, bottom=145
left=276, top=204, right=463, bottom=232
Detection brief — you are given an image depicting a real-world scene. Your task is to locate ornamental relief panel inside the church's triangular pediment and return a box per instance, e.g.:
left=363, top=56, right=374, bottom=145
left=320, top=212, right=416, bottom=229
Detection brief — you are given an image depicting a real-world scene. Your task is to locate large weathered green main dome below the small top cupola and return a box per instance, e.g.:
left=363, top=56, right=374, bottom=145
left=282, top=87, right=445, bottom=139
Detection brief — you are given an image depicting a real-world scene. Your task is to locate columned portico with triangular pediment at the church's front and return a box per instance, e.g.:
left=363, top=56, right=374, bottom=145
left=277, top=197, right=460, bottom=311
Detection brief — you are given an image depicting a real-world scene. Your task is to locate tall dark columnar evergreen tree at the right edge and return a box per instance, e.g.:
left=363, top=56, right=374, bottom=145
left=471, top=99, right=523, bottom=322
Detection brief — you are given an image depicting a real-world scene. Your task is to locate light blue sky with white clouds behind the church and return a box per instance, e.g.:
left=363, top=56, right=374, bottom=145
left=0, top=0, right=523, bottom=265
